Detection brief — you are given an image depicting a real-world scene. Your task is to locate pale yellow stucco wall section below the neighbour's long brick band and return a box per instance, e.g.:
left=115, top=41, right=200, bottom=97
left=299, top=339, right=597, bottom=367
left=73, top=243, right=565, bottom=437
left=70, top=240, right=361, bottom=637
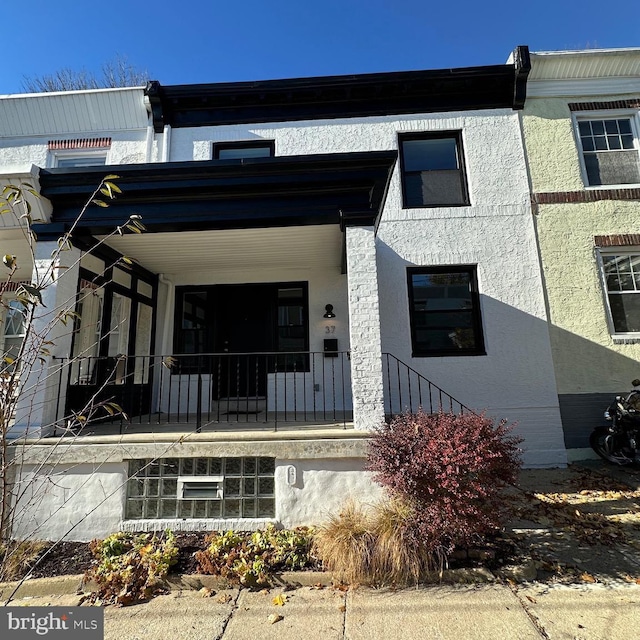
left=537, top=201, right=640, bottom=394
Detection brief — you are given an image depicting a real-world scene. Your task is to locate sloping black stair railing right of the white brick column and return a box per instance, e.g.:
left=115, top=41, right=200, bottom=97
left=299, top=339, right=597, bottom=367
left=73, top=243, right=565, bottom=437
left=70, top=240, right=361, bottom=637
left=382, top=353, right=475, bottom=418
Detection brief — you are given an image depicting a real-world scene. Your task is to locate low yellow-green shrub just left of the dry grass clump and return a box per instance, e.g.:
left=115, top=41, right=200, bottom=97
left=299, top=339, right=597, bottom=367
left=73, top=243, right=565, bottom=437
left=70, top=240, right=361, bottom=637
left=195, top=525, right=314, bottom=587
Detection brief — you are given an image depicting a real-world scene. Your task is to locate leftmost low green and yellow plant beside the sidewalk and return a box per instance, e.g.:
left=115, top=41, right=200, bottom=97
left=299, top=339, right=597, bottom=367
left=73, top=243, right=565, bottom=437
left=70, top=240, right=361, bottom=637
left=85, top=531, right=178, bottom=606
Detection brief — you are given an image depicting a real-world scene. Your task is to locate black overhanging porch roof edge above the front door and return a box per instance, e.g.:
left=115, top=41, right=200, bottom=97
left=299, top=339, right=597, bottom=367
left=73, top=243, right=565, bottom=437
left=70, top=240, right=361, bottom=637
left=36, top=151, right=397, bottom=239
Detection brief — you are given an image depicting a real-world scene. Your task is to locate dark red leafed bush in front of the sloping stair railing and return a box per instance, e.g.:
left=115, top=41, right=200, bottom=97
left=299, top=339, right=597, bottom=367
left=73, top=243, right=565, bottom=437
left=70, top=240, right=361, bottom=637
left=367, top=411, right=521, bottom=554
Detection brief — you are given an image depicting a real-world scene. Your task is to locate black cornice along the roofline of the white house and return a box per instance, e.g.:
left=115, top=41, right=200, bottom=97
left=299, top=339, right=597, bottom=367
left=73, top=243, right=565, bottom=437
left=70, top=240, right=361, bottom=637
left=145, top=46, right=531, bottom=133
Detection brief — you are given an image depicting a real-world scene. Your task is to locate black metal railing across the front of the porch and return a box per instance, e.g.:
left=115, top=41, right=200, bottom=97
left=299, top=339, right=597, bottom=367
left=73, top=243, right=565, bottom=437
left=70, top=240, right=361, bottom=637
left=57, top=351, right=353, bottom=430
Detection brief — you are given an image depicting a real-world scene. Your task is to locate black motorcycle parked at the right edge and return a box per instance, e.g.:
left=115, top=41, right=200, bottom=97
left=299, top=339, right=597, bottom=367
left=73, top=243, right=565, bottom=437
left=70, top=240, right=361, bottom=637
left=589, top=379, right=640, bottom=465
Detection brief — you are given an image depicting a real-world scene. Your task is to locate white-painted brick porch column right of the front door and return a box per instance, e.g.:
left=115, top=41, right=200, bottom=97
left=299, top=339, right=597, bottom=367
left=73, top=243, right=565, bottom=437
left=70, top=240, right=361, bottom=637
left=345, top=227, right=384, bottom=431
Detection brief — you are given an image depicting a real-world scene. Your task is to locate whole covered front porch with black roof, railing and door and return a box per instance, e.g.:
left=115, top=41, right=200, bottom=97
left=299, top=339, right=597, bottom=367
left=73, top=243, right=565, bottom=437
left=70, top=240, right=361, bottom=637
left=16, top=152, right=395, bottom=435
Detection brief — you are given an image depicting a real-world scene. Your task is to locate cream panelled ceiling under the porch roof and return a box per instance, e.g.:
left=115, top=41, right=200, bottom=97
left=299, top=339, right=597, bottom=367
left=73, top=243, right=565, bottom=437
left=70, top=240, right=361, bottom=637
left=100, top=225, right=342, bottom=273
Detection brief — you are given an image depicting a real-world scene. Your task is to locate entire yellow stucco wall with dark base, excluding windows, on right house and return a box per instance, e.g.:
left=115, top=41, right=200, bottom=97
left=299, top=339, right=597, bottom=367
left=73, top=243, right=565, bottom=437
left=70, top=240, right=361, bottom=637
left=522, top=95, right=640, bottom=448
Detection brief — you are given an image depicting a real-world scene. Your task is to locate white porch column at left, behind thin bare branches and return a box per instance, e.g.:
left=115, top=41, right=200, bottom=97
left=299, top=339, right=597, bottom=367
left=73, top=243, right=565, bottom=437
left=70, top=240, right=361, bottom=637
left=10, top=241, right=81, bottom=438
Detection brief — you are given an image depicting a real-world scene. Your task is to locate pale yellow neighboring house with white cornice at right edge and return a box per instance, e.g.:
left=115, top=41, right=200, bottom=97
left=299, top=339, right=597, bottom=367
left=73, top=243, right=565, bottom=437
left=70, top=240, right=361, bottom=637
left=521, top=49, right=640, bottom=457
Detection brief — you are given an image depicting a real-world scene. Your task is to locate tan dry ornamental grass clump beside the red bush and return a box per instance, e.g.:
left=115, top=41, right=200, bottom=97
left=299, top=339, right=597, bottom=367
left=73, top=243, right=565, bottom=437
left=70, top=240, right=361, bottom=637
left=315, top=500, right=445, bottom=585
